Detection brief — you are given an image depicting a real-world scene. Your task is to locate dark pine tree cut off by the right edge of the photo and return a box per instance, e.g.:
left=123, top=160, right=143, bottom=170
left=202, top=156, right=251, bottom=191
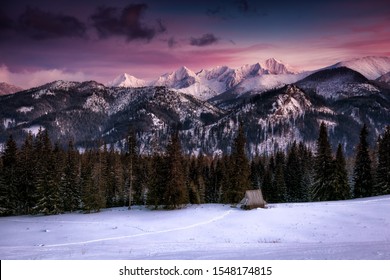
left=375, top=126, right=390, bottom=195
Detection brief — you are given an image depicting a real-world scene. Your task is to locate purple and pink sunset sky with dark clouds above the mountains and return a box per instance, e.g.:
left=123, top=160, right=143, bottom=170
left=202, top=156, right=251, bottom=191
left=0, top=0, right=390, bottom=88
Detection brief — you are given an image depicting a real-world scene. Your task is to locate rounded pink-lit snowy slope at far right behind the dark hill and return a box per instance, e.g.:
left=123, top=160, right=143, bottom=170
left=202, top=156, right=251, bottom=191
left=329, top=56, right=390, bottom=80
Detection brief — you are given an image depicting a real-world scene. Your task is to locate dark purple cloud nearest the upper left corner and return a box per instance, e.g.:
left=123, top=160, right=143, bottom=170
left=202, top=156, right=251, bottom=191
left=15, top=7, right=86, bottom=40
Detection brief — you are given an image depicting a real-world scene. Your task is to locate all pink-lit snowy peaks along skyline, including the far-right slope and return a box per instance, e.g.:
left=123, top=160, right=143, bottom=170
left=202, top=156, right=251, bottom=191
left=106, top=56, right=390, bottom=100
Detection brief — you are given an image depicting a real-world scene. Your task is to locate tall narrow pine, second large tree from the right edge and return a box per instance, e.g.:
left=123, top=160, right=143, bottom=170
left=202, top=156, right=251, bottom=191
left=353, top=125, right=373, bottom=198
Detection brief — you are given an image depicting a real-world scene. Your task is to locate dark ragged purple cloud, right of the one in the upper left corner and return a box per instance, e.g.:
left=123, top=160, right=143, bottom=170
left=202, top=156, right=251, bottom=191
left=91, top=4, right=166, bottom=41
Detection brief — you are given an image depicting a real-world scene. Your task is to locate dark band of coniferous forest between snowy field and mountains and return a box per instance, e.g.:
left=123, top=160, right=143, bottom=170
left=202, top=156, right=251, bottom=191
left=0, top=123, right=390, bottom=215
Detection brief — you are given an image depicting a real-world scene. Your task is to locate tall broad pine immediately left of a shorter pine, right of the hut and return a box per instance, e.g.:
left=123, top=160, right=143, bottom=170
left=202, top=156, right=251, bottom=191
left=312, top=122, right=334, bottom=201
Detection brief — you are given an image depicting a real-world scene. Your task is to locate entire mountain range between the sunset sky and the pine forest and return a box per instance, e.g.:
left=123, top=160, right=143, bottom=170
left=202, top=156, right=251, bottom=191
left=0, top=57, right=390, bottom=155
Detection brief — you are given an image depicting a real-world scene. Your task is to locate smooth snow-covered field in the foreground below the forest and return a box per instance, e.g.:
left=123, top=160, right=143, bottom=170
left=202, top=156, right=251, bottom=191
left=0, top=196, right=390, bottom=260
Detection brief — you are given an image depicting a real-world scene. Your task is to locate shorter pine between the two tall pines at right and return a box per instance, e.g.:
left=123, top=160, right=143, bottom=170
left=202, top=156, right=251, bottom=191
left=331, top=144, right=350, bottom=200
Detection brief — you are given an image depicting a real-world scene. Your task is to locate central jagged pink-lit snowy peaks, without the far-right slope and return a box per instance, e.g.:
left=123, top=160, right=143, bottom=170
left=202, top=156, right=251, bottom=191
left=107, top=58, right=308, bottom=100
